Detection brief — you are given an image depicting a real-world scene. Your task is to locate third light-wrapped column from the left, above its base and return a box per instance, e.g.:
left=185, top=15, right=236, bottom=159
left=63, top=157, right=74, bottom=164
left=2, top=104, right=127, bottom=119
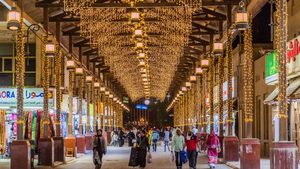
left=54, top=45, right=62, bottom=137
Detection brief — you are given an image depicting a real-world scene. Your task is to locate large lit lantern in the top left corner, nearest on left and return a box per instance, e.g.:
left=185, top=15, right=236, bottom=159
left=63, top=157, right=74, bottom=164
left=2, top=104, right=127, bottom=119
left=7, top=7, right=21, bottom=31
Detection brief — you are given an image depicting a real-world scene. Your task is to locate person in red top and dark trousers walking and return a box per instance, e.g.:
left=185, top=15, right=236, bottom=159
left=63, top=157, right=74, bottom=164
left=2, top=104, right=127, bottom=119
left=185, top=131, right=198, bottom=169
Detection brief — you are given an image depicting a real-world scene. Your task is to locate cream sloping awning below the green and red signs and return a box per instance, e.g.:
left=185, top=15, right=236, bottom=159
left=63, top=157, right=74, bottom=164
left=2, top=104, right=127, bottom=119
left=264, top=78, right=300, bottom=103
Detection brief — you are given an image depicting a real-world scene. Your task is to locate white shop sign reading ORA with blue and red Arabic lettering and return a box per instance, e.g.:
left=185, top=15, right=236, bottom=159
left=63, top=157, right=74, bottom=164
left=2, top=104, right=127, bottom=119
left=0, top=88, right=53, bottom=108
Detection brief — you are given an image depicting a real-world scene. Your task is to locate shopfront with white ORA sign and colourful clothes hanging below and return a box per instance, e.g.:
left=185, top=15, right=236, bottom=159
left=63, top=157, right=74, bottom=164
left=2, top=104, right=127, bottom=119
left=0, top=88, right=55, bottom=155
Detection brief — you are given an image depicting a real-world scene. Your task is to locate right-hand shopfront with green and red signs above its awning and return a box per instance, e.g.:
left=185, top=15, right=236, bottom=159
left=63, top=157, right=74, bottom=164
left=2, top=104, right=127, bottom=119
left=265, top=36, right=300, bottom=148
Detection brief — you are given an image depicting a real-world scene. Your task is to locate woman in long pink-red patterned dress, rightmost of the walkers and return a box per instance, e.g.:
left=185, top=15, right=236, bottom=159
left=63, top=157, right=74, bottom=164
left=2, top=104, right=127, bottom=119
left=206, top=130, right=220, bottom=168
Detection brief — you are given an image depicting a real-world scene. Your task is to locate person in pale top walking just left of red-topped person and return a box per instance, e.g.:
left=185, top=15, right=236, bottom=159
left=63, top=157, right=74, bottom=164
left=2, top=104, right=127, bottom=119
left=171, top=128, right=184, bottom=169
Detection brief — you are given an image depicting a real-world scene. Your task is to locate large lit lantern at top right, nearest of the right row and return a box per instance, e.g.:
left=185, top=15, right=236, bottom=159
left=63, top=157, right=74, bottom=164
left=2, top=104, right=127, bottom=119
left=235, top=0, right=249, bottom=31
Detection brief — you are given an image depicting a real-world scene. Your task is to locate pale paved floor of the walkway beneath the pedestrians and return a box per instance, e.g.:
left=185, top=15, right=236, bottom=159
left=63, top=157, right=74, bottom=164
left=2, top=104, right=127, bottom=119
left=0, top=147, right=230, bottom=169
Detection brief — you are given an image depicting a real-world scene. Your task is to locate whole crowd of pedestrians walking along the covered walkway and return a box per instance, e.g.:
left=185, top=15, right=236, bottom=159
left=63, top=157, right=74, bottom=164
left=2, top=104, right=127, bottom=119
left=93, top=128, right=220, bottom=169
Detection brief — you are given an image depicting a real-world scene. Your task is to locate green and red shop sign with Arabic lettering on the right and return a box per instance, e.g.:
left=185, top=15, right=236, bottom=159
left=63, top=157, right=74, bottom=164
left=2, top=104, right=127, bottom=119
left=265, top=36, right=300, bottom=85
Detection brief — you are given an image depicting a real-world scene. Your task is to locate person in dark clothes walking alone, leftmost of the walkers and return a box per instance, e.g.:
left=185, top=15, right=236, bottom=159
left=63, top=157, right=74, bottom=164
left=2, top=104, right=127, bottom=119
left=93, top=129, right=106, bottom=169
